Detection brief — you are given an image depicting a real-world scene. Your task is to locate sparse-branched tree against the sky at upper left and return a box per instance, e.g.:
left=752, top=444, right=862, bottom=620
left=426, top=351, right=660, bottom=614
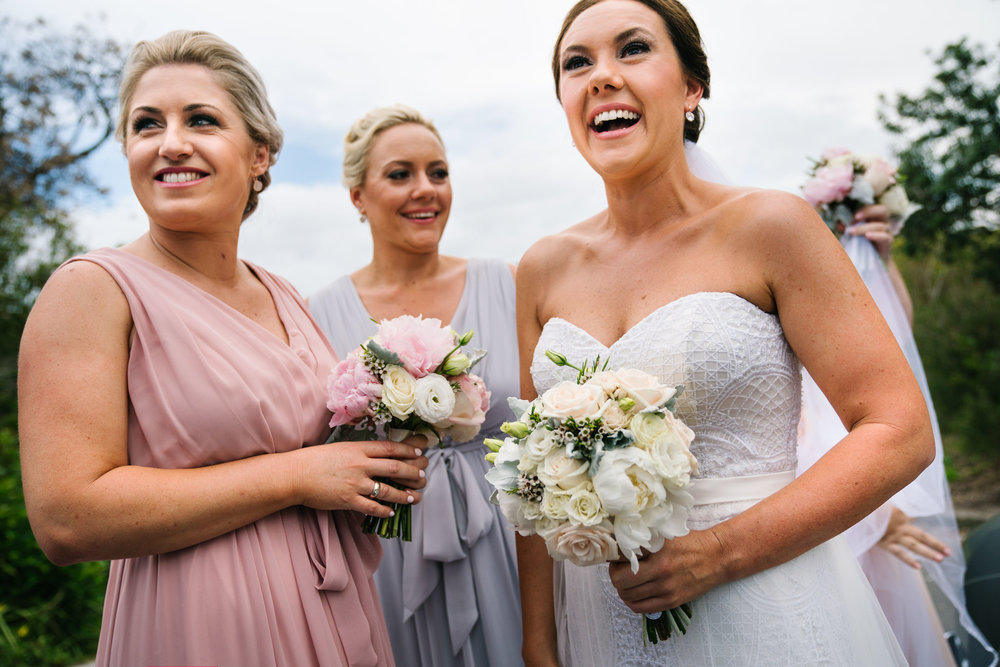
left=0, top=18, right=124, bottom=414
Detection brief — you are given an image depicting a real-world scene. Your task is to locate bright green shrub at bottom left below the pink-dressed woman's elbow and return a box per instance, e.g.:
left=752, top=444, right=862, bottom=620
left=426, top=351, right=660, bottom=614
left=0, top=426, right=108, bottom=667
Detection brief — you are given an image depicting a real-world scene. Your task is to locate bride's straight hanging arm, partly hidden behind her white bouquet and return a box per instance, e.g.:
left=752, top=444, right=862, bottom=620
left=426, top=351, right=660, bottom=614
left=516, top=245, right=558, bottom=667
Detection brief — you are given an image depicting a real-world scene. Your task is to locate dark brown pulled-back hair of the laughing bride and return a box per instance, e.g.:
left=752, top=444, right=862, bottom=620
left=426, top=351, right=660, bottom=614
left=552, top=0, right=712, bottom=142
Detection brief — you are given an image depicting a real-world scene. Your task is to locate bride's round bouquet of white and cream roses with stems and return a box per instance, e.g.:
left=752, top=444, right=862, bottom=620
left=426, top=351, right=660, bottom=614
left=485, top=351, right=698, bottom=644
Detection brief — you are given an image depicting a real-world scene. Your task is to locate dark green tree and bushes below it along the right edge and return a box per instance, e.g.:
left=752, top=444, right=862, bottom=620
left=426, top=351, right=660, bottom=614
left=880, top=40, right=1000, bottom=458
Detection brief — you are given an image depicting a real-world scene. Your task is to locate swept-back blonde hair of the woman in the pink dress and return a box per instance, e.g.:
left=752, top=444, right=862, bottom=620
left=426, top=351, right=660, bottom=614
left=115, top=30, right=283, bottom=220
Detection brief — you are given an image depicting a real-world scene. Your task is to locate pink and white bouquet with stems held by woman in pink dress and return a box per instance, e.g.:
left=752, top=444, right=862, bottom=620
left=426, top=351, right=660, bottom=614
left=326, top=315, right=490, bottom=541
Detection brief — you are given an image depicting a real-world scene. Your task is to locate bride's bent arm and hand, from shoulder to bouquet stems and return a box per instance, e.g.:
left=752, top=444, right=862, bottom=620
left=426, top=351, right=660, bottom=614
left=611, top=193, right=934, bottom=612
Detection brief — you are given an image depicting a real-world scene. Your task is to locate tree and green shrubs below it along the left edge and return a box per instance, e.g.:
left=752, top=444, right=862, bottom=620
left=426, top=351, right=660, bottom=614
left=0, top=18, right=124, bottom=665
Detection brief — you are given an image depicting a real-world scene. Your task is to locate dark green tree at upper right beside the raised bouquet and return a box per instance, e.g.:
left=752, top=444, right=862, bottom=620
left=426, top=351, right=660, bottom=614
left=880, top=39, right=1000, bottom=286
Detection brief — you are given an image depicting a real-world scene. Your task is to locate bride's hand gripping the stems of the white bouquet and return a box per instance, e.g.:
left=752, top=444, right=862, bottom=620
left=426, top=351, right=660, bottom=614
left=608, top=530, right=727, bottom=613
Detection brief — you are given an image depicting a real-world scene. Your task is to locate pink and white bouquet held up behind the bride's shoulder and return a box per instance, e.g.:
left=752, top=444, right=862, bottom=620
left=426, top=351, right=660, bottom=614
left=802, top=148, right=920, bottom=234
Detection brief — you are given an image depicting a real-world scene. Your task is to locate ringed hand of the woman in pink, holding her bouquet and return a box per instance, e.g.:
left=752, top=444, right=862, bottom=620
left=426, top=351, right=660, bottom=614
left=289, top=437, right=427, bottom=518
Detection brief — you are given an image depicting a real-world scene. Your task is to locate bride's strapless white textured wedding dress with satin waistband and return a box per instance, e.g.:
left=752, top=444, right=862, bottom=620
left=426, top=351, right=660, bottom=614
left=531, top=292, right=906, bottom=667
